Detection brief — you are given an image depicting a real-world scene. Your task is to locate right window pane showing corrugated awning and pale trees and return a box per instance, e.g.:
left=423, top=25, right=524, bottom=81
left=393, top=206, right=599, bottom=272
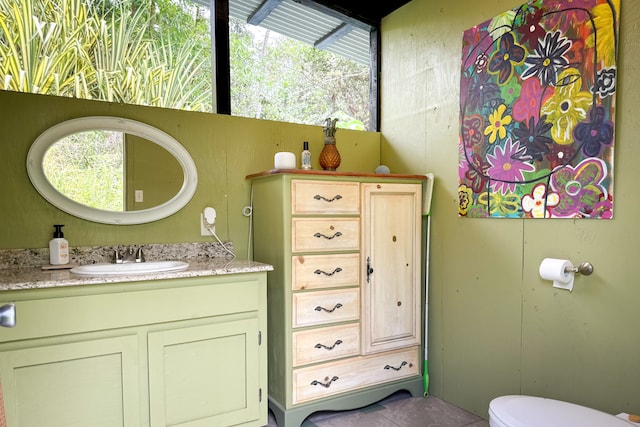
left=229, top=0, right=371, bottom=129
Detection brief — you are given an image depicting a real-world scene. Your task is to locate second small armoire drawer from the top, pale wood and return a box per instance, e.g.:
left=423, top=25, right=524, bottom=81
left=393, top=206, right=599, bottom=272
left=291, top=218, right=360, bottom=252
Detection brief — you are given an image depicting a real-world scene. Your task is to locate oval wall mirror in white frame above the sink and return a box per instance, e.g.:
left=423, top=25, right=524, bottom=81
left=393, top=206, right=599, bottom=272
left=27, top=116, right=198, bottom=225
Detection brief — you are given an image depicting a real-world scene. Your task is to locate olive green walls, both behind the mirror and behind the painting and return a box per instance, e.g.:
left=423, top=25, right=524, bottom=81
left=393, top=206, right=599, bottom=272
left=5, top=0, right=640, bottom=418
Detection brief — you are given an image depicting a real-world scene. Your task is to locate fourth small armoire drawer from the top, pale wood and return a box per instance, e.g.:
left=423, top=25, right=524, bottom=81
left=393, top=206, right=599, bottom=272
left=291, top=288, right=360, bottom=328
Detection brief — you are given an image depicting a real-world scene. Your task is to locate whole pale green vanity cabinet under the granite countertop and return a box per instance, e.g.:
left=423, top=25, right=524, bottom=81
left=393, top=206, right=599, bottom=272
left=0, top=272, right=268, bottom=427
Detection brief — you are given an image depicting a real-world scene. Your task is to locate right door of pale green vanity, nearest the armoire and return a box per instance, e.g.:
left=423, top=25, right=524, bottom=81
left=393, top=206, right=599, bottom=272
left=149, top=318, right=266, bottom=427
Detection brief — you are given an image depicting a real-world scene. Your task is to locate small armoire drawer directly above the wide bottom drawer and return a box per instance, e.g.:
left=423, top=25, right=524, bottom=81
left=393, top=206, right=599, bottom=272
left=291, top=323, right=360, bottom=367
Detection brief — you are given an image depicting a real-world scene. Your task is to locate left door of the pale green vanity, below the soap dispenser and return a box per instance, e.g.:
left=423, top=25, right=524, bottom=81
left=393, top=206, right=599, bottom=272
left=0, top=335, right=141, bottom=427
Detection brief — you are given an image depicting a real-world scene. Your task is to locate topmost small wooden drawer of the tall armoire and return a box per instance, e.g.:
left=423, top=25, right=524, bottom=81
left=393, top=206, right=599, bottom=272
left=291, top=179, right=360, bottom=215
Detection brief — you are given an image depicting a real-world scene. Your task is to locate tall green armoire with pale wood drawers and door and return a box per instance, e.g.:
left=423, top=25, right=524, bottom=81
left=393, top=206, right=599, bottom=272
left=248, top=171, right=425, bottom=427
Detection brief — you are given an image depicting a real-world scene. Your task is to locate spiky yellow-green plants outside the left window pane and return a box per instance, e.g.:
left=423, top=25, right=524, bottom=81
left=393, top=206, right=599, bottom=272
left=0, top=0, right=211, bottom=111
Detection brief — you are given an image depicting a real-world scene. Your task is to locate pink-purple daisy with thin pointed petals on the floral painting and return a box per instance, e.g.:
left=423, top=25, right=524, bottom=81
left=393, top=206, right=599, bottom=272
left=487, top=138, right=535, bottom=194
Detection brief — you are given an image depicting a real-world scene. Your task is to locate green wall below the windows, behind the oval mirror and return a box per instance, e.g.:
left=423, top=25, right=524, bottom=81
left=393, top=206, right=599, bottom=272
left=0, top=91, right=380, bottom=259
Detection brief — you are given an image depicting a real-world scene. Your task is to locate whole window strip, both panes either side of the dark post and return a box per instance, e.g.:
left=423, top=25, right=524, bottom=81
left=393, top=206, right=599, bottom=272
left=0, top=0, right=377, bottom=129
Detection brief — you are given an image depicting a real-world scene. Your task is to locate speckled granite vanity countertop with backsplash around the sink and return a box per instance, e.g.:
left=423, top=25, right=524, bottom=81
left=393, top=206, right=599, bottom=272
left=0, top=243, right=273, bottom=292
